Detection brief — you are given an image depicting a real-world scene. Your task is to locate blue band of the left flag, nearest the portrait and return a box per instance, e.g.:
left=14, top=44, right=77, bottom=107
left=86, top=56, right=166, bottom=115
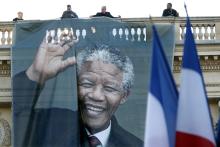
left=150, top=25, right=178, bottom=147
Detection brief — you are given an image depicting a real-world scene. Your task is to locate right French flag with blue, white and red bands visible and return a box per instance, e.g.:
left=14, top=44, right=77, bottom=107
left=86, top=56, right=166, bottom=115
left=176, top=10, right=215, bottom=147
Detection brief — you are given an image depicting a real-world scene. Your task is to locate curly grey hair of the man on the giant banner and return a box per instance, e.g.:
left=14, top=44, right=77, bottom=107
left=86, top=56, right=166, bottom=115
left=77, top=45, right=134, bottom=92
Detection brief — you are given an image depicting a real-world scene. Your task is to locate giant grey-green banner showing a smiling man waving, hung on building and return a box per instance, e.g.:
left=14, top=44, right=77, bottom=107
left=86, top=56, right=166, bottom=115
left=12, top=18, right=175, bottom=147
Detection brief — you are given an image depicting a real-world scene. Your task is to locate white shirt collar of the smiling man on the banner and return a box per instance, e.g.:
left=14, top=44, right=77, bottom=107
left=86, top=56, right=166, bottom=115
left=86, top=121, right=111, bottom=147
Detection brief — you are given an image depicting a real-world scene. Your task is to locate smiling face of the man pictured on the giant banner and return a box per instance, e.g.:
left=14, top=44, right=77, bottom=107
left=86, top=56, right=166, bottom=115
left=79, top=61, right=126, bottom=133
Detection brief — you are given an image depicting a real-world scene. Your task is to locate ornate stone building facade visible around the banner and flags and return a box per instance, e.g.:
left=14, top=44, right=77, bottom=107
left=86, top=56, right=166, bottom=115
left=0, top=17, right=220, bottom=147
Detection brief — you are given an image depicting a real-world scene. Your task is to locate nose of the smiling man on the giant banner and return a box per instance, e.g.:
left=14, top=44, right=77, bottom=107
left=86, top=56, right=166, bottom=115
left=90, top=85, right=105, bottom=101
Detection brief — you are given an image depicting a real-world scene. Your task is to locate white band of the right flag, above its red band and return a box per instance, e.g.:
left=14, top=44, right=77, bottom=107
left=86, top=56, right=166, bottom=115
left=177, top=68, right=214, bottom=142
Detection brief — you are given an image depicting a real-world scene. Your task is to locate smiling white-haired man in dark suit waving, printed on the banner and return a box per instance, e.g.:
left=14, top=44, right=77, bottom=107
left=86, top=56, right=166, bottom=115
left=13, top=33, right=143, bottom=147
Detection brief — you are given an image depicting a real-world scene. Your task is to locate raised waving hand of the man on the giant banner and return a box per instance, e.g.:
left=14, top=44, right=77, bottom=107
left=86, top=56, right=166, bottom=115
left=26, top=30, right=78, bottom=84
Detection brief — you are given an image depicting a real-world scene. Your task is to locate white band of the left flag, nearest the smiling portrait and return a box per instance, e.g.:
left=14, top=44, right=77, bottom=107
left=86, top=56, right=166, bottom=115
left=144, top=92, right=169, bottom=147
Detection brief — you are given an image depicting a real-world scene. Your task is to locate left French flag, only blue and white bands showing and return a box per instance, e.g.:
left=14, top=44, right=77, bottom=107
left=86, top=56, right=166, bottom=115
left=144, top=25, right=178, bottom=147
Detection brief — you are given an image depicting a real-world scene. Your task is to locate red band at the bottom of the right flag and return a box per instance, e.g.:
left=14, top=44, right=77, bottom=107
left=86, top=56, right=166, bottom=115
left=176, top=132, right=215, bottom=147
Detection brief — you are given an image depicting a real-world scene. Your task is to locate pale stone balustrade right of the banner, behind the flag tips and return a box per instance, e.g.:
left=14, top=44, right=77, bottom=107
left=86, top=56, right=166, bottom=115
left=122, top=17, right=220, bottom=43
